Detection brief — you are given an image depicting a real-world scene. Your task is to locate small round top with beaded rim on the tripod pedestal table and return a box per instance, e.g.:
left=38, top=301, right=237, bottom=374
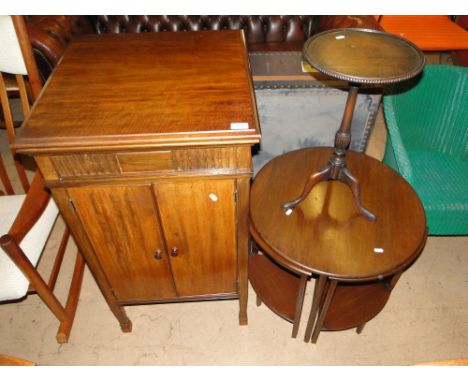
left=303, top=28, right=425, bottom=84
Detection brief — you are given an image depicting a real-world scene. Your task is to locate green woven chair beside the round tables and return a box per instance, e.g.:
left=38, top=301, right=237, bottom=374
left=383, top=65, right=468, bottom=235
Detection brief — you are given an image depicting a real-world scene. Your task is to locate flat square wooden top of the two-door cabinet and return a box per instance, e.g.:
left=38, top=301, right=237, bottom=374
left=15, top=31, right=259, bottom=152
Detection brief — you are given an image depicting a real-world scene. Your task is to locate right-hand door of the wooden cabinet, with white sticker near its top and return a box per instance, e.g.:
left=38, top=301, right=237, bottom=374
left=154, top=180, right=237, bottom=297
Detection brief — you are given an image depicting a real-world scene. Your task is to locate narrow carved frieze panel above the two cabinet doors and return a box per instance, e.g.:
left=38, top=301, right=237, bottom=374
left=47, top=146, right=252, bottom=179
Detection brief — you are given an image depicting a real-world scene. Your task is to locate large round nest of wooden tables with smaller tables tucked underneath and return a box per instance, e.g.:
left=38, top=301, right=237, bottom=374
left=249, top=147, right=427, bottom=343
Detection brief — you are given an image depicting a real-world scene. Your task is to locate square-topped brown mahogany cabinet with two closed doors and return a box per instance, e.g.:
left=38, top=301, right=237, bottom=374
left=15, top=31, right=260, bottom=331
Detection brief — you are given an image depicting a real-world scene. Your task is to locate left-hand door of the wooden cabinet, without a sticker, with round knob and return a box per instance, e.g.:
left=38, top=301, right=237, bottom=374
left=68, top=186, right=175, bottom=301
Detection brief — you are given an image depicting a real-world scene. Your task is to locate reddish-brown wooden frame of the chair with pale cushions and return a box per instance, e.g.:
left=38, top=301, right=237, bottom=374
left=0, top=16, right=85, bottom=343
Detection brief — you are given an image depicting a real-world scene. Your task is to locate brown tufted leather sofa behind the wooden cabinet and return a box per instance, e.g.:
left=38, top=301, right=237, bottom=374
left=27, top=15, right=381, bottom=80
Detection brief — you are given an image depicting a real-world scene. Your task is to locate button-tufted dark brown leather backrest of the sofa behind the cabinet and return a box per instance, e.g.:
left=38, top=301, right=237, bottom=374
left=91, top=15, right=318, bottom=44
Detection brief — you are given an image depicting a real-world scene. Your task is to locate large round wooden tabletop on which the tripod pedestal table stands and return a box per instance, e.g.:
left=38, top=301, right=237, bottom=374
left=250, top=147, right=426, bottom=281
